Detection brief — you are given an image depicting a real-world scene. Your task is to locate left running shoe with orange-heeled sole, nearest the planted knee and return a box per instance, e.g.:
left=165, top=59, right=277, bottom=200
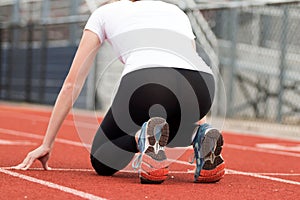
left=132, top=117, right=169, bottom=184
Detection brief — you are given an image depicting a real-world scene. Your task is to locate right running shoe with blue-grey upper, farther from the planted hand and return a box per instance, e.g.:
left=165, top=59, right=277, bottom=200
left=192, top=124, right=225, bottom=183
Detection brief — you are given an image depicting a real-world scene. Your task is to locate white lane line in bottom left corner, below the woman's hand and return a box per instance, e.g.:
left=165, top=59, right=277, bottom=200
left=0, top=168, right=104, bottom=200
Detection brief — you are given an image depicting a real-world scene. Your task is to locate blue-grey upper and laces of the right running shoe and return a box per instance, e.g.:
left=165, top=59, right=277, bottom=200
left=189, top=124, right=211, bottom=181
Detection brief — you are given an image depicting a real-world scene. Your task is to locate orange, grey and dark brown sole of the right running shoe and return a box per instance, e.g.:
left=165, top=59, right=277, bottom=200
left=195, top=129, right=225, bottom=183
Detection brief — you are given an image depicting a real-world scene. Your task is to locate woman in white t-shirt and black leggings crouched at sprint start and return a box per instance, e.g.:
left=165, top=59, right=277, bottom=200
left=13, top=0, right=225, bottom=183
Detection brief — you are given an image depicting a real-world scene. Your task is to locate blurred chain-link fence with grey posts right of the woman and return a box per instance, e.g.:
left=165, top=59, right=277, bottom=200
left=202, top=3, right=300, bottom=125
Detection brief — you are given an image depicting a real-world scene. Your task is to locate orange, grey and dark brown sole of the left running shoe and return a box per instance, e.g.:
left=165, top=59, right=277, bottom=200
left=140, top=117, right=169, bottom=184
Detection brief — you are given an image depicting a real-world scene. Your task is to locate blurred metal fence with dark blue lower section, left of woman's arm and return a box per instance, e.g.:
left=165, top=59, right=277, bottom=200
left=0, top=0, right=90, bottom=107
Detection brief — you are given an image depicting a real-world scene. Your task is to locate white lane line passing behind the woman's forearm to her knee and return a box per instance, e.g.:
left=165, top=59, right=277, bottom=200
left=0, top=128, right=91, bottom=148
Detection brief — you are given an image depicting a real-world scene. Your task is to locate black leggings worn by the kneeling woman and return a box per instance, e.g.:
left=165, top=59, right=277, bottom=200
left=91, top=67, right=215, bottom=175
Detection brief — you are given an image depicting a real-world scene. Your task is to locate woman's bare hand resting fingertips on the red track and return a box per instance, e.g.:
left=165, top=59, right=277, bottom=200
left=11, top=145, right=51, bottom=170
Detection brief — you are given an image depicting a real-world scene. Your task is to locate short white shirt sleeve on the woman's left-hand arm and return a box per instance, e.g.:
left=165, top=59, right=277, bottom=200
left=84, top=9, right=106, bottom=42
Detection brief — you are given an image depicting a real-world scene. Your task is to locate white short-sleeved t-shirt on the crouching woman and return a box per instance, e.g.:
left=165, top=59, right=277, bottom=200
left=85, top=0, right=211, bottom=75
